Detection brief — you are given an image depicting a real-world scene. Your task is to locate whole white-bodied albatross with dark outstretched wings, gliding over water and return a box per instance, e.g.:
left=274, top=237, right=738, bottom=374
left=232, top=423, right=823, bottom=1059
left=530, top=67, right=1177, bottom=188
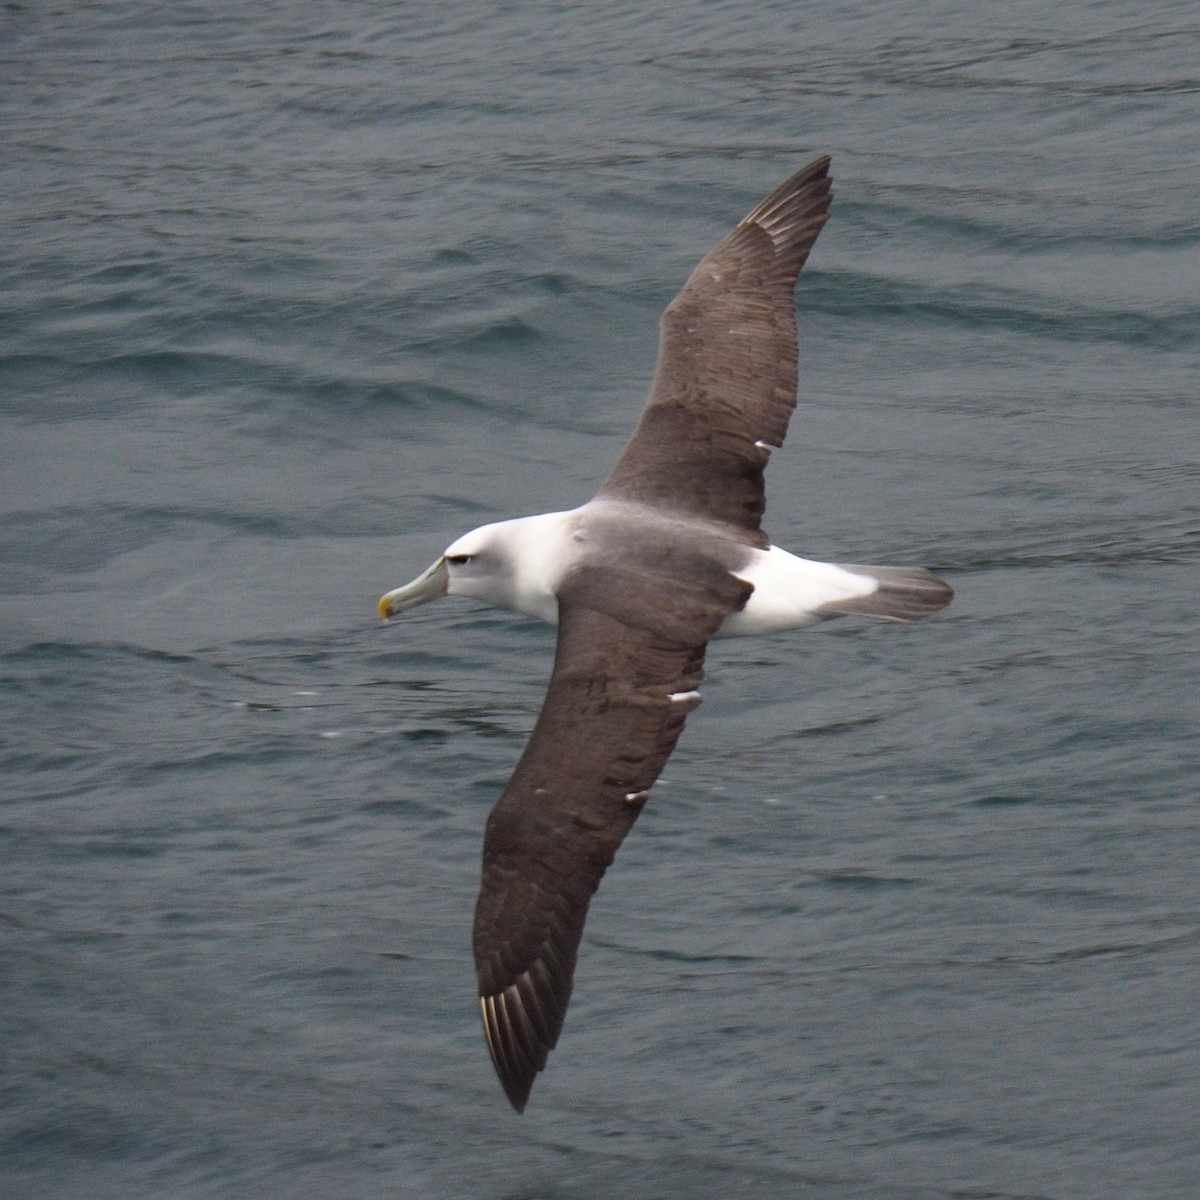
left=379, top=157, right=954, bottom=1112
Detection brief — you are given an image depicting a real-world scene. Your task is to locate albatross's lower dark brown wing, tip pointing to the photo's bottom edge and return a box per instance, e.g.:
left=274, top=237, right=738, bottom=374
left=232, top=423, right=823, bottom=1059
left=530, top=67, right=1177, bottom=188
left=474, top=556, right=749, bottom=1112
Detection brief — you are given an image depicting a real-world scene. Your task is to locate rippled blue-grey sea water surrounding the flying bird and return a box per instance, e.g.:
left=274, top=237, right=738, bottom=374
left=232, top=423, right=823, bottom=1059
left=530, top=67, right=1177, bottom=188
left=0, top=0, right=1200, bottom=1200
